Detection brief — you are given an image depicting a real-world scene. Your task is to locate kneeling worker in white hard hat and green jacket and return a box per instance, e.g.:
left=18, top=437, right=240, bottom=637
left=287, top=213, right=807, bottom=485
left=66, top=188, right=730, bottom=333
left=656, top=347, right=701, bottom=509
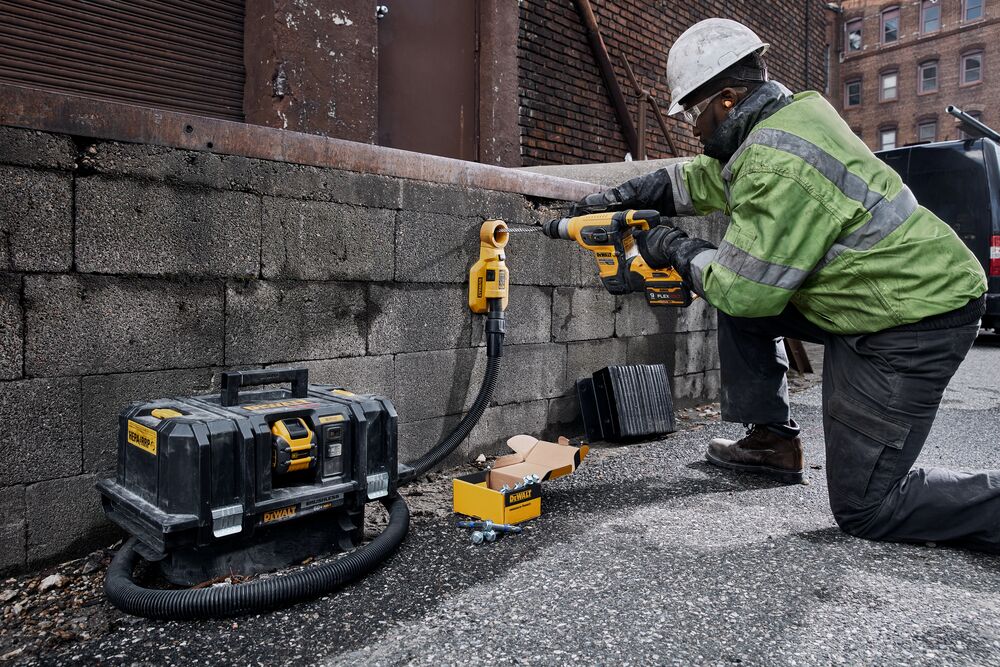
left=575, top=19, right=1000, bottom=551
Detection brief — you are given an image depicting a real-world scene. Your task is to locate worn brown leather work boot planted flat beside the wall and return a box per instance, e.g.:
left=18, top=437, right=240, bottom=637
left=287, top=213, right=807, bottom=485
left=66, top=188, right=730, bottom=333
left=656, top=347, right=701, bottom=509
left=705, top=422, right=805, bottom=484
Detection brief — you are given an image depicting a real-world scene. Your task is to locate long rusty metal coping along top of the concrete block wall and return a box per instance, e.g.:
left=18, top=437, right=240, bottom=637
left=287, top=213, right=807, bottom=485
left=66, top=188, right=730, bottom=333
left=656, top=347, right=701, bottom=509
left=0, top=84, right=600, bottom=201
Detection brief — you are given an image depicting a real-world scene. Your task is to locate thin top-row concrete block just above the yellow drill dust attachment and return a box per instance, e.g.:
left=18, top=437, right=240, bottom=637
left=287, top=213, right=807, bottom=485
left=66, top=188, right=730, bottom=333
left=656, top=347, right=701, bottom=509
left=400, top=179, right=527, bottom=222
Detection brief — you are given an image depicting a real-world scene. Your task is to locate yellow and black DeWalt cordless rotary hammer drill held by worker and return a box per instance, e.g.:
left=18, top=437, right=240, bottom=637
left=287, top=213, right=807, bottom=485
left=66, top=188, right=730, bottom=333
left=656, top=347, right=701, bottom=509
left=542, top=210, right=691, bottom=307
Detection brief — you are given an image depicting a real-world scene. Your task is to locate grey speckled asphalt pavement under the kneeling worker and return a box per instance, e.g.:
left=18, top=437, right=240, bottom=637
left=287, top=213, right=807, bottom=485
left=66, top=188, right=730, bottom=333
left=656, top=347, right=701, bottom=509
left=15, top=337, right=1000, bottom=665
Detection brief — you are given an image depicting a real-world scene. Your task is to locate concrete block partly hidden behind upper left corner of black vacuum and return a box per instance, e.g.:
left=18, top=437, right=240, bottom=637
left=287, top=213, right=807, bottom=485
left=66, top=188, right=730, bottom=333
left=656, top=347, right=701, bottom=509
left=81, top=368, right=219, bottom=477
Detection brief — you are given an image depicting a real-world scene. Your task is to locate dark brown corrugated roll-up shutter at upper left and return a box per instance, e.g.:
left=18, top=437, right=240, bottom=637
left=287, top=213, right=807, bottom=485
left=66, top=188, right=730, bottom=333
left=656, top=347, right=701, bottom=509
left=0, top=0, right=245, bottom=121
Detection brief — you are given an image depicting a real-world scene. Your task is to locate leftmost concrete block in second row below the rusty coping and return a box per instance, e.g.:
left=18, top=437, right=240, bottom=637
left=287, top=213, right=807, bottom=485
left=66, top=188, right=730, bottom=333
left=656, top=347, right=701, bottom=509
left=0, top=167, right=73, bottom=271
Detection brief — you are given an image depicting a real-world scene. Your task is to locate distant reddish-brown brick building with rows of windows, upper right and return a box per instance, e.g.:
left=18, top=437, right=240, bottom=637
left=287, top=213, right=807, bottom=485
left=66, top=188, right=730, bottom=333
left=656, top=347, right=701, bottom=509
left=829, top=0, right=1000, bottom=150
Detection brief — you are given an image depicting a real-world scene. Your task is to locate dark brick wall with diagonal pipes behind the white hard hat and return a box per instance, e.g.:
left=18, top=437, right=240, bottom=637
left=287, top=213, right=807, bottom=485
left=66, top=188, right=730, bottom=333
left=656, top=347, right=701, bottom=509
left=518, top=0, right=832, bottom=166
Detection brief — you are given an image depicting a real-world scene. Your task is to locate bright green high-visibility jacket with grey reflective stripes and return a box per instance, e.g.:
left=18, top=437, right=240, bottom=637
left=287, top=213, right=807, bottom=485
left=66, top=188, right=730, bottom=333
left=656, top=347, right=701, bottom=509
left=672, top=91, right=986, bottom=334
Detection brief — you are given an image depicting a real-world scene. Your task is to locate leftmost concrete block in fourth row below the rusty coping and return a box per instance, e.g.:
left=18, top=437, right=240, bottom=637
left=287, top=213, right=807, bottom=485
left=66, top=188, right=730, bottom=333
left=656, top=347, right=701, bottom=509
left=0, top=378, right=82, bottom=486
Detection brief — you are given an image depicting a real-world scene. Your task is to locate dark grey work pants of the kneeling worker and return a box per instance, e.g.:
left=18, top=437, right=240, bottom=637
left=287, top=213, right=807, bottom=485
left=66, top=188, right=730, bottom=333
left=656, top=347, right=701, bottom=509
left=719, top=306, right=1000, bottom=552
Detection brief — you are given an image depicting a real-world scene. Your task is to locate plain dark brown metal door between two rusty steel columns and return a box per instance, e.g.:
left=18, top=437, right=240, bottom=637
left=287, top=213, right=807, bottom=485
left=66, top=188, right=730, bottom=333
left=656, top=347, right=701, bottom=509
left=378, top=0, right=480, bottom=160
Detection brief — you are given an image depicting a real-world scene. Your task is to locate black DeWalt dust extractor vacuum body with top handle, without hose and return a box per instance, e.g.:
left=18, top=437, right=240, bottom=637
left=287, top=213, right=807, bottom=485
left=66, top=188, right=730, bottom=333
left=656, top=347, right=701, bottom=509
left=97, top=369, right=398, bottom=586
